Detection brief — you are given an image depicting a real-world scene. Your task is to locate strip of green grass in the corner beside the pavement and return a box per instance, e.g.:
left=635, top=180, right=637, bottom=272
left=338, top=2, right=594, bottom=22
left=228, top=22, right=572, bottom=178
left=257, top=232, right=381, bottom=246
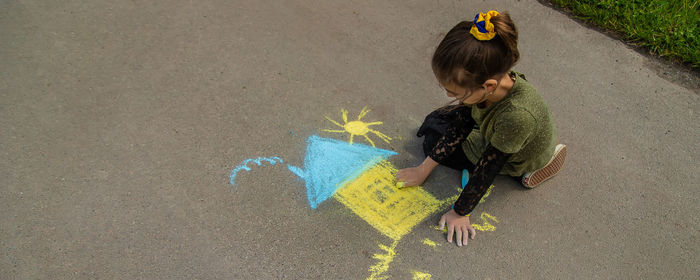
left=550, top=0, right=700, bottom=69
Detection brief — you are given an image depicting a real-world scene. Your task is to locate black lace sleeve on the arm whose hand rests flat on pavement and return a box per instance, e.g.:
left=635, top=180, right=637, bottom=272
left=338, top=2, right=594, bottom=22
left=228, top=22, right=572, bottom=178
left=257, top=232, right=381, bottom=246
left=453, top=145, right=512, bottom=216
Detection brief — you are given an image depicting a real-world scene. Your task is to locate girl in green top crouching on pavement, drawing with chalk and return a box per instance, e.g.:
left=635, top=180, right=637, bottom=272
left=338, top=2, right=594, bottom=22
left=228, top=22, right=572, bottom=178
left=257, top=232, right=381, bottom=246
left=396, top=11, right=566, bottom=246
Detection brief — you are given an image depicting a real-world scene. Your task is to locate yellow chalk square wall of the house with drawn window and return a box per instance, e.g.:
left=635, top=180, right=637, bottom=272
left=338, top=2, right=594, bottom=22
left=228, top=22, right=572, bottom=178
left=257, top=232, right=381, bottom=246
left=335, top=161, right=443, bottom=240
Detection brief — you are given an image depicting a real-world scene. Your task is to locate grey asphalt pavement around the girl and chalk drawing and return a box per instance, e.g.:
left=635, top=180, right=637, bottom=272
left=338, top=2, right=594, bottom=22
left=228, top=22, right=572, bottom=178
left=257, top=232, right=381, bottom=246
left=0, top=1, right=700, bottom=279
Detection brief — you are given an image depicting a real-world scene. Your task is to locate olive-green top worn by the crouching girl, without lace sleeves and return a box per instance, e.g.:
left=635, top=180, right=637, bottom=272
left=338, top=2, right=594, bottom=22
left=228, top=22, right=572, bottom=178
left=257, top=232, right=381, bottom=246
left=462, top=72, right=557, bottom=176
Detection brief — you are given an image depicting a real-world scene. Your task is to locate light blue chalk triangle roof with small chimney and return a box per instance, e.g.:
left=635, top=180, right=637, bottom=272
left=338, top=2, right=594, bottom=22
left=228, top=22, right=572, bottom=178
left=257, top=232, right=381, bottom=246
left=288, top=135, right=396, bottom=209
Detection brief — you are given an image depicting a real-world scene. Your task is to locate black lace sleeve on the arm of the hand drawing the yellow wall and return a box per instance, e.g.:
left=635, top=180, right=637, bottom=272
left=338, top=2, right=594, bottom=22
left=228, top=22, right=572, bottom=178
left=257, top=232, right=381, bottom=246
left=428, top=107, right=474, bottom=162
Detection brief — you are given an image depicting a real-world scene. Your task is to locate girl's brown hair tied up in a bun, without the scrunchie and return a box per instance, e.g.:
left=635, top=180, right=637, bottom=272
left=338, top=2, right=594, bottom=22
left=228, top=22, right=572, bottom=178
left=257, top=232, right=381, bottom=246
left=432, top=13, right=520, bottom=89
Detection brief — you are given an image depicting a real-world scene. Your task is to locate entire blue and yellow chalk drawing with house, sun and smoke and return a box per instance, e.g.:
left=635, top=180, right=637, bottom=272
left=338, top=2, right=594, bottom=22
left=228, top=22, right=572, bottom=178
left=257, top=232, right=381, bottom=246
left=230, top=107, right=508, bottom=279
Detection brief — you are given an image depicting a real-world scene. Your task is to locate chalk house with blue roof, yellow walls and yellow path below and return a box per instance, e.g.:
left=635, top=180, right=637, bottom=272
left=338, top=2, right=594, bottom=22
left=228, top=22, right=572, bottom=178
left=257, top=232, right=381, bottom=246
left=288, top=135, right=432, bottom=279
